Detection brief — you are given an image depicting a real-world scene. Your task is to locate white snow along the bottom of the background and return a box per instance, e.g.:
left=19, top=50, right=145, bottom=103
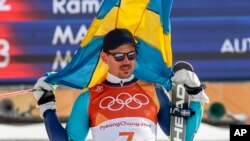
left=0, top=123, right=229, bottom=141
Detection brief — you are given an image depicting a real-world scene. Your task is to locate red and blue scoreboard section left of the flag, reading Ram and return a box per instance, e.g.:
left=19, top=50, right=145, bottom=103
left=0, top=0, right=101, bottom=84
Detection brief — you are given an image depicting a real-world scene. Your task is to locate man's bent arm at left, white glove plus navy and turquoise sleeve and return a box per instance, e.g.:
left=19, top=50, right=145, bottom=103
left=33, top=77, right=89, bottom=141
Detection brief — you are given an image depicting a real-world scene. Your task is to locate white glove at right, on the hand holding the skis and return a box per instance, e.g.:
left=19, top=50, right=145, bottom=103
left=171, top=69, right=209, bottom=103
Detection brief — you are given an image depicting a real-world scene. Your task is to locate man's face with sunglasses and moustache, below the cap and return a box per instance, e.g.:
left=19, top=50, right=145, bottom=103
left=101, top=44, right=136, bottom=79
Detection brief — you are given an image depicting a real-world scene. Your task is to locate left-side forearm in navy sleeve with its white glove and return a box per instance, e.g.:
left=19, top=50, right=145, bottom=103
left=33, top=76, right=68, bottom=141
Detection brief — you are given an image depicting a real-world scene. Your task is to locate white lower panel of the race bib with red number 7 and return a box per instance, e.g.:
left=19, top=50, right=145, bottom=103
left=91, top=117, right=157, bottom=141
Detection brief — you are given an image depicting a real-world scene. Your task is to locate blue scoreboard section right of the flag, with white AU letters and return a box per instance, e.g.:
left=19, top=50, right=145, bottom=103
left=171, top=0, right=250, bottom=81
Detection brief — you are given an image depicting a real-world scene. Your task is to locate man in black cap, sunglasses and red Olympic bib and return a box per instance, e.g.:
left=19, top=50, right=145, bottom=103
left=34, top=29, right=209, bottom=141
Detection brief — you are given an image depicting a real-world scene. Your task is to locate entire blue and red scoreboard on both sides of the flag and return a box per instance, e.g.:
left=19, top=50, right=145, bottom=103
left=0, top=0, right=250, bottom=84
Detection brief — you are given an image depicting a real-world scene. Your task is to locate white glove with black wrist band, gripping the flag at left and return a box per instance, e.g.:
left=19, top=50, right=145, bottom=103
left=33, top=76, right=56, bottom=119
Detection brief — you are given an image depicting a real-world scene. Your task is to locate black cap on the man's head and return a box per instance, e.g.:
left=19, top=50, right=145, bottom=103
left=102, top=28, right=137, bottom=52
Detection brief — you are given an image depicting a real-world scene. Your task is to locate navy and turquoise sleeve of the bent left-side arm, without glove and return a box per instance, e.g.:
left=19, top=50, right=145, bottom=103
left=44, top=91, right=89, bottom=141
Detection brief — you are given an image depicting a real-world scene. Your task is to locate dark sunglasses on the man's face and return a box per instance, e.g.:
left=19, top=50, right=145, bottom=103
left=107, top=51, right=136, bottom=62
